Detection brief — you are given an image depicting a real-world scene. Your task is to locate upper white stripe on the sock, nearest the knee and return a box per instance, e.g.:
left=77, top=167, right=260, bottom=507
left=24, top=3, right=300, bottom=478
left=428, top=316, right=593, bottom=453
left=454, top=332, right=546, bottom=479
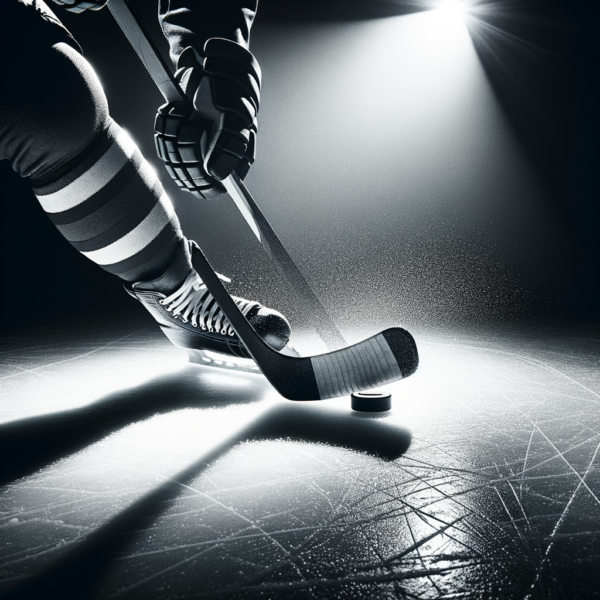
left=37, top=130, right=137, bottom=213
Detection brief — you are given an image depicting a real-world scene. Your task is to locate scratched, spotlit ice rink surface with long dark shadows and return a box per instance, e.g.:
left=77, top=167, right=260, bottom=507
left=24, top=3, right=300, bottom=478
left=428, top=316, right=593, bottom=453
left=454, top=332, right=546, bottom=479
left=0, top=316, right=600, bottom=600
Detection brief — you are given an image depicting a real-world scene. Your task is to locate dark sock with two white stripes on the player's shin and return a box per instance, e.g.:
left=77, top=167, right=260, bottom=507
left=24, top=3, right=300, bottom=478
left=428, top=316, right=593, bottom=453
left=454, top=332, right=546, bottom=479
left=32, top=121, right=183, bottom=281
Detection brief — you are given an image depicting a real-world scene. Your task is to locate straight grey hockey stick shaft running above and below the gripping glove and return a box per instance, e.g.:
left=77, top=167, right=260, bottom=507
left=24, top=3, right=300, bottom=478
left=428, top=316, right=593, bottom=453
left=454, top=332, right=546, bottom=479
left=108, top=0, right=347, bottom=350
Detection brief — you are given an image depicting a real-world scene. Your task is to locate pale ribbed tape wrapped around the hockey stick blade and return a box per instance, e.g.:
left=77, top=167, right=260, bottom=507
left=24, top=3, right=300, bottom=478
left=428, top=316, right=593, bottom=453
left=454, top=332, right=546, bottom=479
left=310, top=334, right=402, bottom=399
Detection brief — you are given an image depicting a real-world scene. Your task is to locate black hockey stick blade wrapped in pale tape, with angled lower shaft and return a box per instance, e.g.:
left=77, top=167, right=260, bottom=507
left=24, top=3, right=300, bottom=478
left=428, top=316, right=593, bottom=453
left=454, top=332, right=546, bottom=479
left=192, top=244, right=419, bottom=400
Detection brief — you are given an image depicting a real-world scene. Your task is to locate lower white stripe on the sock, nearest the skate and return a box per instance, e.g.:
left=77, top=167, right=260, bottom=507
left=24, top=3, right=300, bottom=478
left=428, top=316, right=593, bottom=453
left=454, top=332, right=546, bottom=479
left=82, top=193, right=175, bottom=265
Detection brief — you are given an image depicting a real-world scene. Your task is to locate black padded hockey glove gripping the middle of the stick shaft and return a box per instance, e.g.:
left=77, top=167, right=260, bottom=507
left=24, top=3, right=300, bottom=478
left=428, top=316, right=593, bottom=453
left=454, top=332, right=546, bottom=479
left=154, top=38, right=261, bottom=198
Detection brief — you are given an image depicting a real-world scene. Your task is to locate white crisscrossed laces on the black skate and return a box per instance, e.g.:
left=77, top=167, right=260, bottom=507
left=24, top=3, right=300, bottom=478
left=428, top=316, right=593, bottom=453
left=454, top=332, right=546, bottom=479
left=160, top=271, right=260, bottom=337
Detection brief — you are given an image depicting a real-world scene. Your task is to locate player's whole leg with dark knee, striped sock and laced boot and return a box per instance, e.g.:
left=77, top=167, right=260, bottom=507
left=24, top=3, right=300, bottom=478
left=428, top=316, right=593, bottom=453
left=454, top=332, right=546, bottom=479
left=0, top=2, right=289, bottom=354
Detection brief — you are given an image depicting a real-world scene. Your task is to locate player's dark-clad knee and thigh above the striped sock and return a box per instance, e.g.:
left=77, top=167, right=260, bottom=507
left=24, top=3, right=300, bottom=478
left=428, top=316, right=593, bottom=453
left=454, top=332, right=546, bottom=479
left=0, top=2, right=108, bottom=181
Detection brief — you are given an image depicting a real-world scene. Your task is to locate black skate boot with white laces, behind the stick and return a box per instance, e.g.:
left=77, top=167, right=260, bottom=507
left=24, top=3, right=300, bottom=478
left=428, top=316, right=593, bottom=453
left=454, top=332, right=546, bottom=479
left=125, top=242, right=291, bottom=362
